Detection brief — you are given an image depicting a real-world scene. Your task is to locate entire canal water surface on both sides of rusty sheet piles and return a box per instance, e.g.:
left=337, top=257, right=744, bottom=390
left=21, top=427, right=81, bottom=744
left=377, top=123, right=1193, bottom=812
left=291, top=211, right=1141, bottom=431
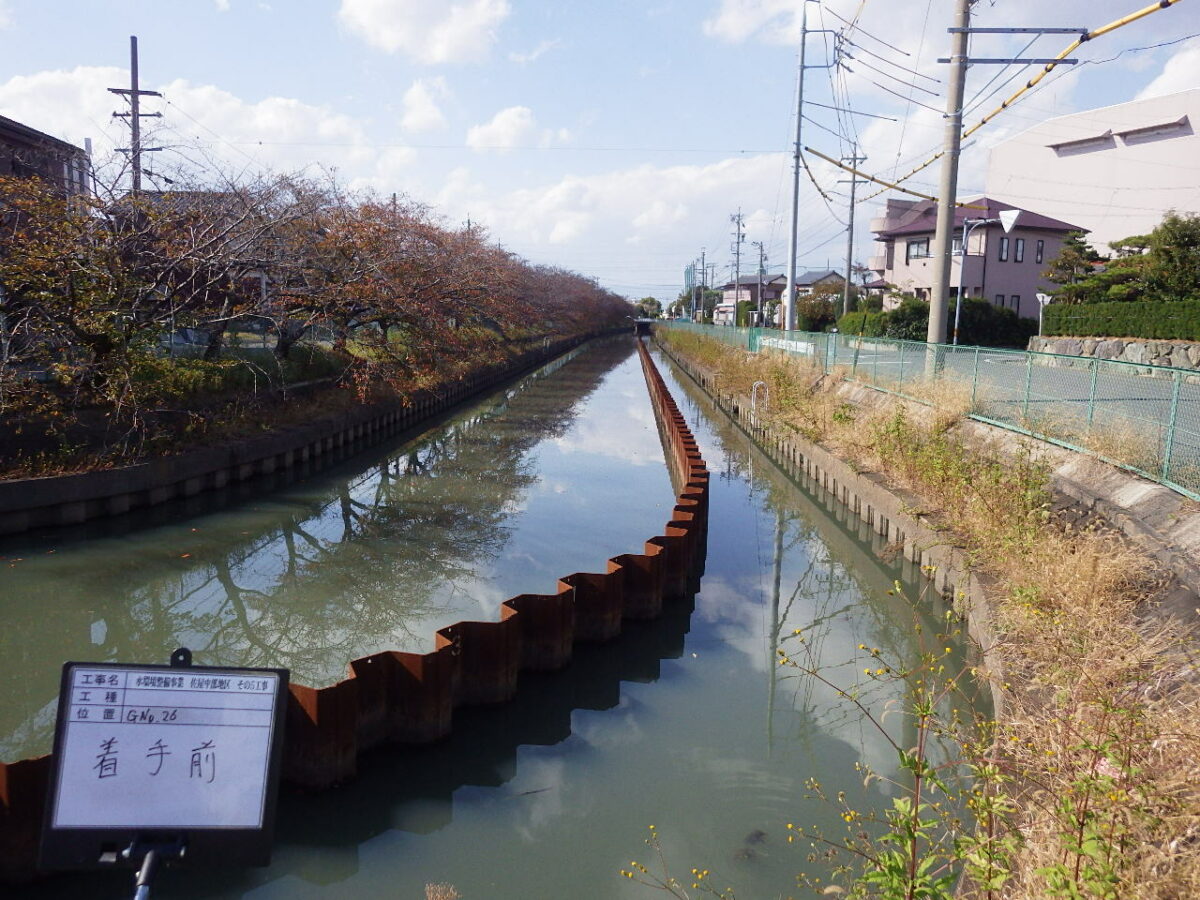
left=0, top=338, right=974, bottom=900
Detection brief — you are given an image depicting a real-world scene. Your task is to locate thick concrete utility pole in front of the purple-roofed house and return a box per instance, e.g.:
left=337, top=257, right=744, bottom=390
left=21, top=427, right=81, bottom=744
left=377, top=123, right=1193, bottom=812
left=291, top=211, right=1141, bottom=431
left=925, top=0, right=973, bottom=343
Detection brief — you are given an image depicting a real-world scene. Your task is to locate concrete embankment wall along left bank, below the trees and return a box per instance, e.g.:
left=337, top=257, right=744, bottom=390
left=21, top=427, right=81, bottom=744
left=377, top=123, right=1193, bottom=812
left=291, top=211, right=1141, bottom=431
left=0, top=330, right=624, bottom=535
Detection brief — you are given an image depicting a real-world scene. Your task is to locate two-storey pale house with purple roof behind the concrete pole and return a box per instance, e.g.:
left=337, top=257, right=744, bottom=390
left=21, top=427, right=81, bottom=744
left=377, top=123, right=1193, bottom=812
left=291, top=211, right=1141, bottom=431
left=868, top=197, right=1086, bottom=318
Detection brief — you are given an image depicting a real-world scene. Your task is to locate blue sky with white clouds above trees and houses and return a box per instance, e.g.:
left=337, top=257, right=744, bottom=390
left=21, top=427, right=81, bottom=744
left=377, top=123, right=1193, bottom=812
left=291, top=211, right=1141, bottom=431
left=0, top=0, right=1200, bottom=301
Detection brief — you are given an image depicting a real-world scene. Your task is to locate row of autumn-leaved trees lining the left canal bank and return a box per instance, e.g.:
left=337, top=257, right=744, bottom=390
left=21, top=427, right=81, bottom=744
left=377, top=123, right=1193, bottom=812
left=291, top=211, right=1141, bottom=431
left=0, top=173, right=634, bottom=476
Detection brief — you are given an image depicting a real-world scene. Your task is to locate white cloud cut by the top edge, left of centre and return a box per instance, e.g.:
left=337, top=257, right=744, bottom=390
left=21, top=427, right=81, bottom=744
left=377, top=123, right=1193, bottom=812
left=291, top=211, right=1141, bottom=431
left=337, top=0, right=511, bottom=64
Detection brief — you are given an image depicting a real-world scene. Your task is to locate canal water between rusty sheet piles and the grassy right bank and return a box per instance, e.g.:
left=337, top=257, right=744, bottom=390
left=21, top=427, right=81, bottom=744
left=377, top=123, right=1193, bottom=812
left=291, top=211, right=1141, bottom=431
left=4, top=340, right=979, bottom=900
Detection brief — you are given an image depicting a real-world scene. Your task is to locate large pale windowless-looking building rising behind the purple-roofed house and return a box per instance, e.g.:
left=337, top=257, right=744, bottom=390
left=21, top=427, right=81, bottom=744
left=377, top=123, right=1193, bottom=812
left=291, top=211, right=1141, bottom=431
left=986, top=88, right=1200, bottom=253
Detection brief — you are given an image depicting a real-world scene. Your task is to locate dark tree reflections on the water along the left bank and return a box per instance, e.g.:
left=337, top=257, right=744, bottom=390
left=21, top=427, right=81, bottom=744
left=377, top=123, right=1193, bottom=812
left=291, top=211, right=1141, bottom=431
left=0, top=341, right=649, bottom=760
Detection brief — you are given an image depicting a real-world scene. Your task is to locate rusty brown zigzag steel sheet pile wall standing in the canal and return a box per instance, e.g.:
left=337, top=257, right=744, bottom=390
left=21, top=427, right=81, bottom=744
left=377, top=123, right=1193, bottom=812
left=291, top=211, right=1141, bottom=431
left=0, top=340, right=708, bottom=881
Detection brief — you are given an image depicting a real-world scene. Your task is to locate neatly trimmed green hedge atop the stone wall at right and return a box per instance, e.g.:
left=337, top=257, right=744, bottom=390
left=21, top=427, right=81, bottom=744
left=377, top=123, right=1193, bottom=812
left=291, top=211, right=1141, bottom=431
left=1042, top=300, right=1200, bottom=341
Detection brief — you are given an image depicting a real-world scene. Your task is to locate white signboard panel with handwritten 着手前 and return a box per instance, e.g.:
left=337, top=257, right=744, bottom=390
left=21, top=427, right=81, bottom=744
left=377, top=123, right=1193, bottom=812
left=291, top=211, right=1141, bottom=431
left=49, top=664, right=281, bottom=829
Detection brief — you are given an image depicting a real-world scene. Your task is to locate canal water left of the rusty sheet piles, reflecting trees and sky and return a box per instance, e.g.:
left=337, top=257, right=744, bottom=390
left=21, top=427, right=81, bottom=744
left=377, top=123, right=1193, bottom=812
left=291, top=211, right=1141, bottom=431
left=0, top=340, right=672, bottom=760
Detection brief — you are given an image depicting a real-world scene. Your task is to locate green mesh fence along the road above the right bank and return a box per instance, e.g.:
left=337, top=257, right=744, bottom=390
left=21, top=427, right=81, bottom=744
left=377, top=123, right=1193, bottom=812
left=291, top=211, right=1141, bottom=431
left=658, top=322, right=1200, bottom=499
